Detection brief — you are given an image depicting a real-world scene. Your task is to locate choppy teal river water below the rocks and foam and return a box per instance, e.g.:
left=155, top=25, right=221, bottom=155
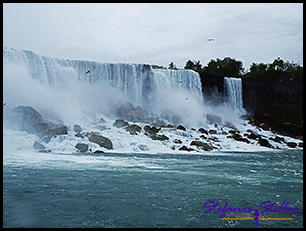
left=3, top=151, right=303, bottom=228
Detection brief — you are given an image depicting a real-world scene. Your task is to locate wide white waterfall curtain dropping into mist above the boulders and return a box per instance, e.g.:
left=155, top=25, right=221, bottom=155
left=3, top=48, right=203, bottom=122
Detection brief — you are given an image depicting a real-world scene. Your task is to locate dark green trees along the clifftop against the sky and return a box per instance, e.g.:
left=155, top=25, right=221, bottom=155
left=152, top=57, right=303, bottom=77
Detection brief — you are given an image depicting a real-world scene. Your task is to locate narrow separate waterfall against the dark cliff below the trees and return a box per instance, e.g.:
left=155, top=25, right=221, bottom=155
left=224, top=77, right=243, bottom=109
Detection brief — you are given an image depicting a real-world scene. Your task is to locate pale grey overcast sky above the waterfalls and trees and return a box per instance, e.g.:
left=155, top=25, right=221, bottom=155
left=3, top=3, right=303, bottom=68
